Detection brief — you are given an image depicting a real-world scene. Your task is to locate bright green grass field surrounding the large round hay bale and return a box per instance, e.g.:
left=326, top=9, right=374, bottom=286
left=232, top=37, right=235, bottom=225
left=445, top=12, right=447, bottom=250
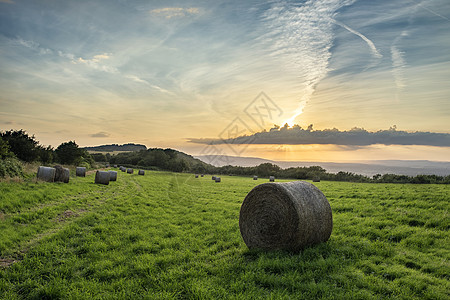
left=0, top=171, right=450, bottom=299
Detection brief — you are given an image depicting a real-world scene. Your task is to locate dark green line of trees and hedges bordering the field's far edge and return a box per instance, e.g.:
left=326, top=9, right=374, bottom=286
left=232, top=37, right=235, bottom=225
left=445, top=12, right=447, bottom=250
left=0, top=129, right=450, bottom=184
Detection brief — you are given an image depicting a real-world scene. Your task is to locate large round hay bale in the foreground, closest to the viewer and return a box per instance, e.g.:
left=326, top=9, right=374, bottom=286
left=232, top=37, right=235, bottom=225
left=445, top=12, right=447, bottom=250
left=239, top=181, right=333, bottom=251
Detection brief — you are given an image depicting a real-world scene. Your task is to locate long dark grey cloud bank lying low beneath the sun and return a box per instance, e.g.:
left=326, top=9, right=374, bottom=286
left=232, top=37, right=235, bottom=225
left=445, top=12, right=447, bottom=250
left=189, top=125, right=450, bottom=147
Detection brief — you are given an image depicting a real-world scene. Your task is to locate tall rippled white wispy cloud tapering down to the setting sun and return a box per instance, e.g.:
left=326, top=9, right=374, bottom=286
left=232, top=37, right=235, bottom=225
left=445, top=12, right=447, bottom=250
left=265, top=0, right=356, bottom=123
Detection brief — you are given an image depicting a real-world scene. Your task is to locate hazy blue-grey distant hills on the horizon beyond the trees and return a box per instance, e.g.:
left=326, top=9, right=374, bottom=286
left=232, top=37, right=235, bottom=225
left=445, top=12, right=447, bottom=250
left=195, top=155, right=450, bottom=177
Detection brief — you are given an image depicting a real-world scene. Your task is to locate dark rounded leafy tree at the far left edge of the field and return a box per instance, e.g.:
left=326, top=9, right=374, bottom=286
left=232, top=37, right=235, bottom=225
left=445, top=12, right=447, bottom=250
left=0, top=129, right=39, bottom=162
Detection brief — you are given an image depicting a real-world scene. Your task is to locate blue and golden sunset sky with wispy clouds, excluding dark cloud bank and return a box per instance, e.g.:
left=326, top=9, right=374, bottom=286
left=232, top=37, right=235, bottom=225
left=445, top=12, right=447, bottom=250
left=0, top=0, right=450, bottom=161
